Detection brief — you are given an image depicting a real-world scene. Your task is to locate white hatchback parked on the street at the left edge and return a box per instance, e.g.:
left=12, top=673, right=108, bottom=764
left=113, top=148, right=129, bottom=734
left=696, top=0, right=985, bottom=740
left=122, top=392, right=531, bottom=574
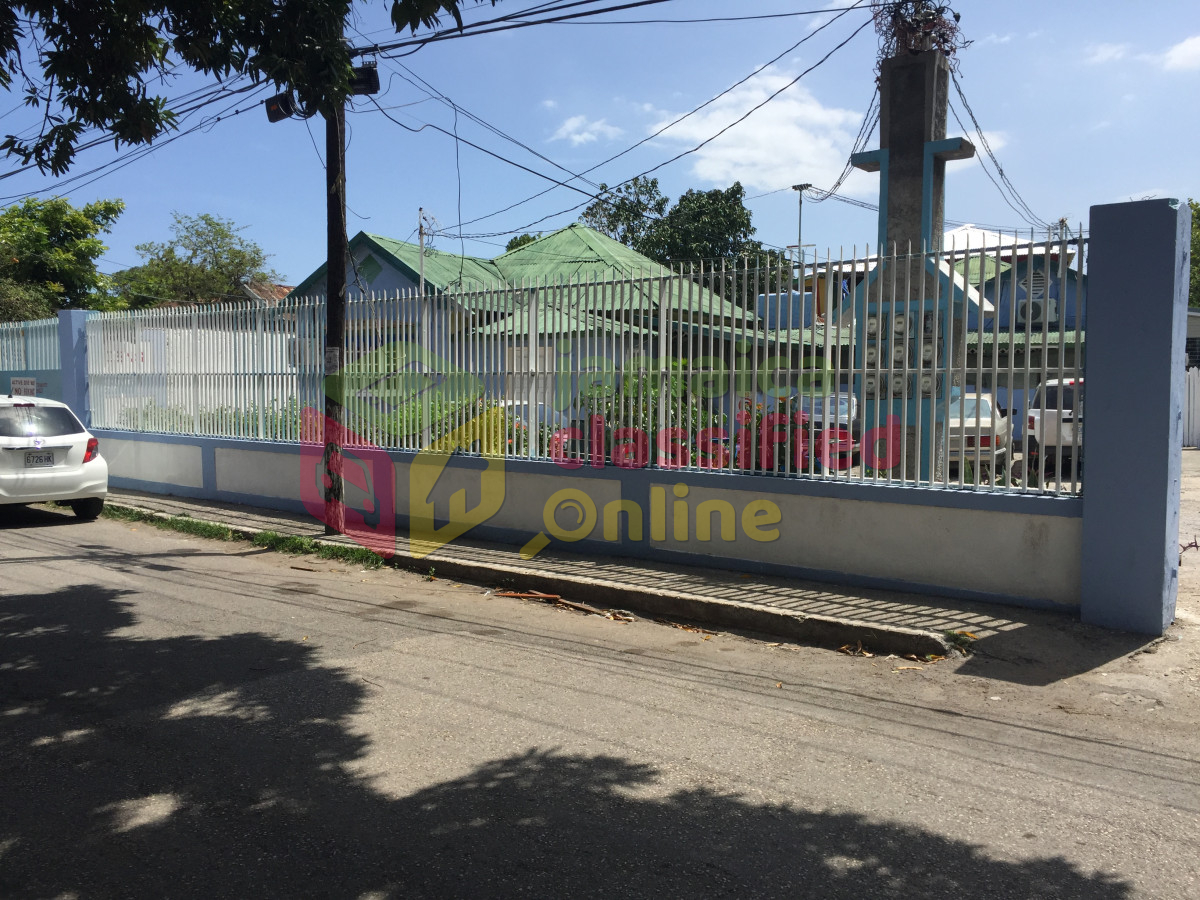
left=0, top=395, right=108, bottom=518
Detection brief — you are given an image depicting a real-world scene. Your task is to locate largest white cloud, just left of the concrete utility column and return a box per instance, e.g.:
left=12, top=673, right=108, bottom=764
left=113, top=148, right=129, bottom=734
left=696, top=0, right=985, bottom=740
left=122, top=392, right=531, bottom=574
left=650, top=72, right=878, bottom=197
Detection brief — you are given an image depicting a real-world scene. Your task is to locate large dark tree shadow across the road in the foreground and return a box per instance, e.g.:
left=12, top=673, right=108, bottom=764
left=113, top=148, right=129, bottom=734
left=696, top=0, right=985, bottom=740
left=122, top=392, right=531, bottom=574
left=0, top=584, right=1129, bottom=900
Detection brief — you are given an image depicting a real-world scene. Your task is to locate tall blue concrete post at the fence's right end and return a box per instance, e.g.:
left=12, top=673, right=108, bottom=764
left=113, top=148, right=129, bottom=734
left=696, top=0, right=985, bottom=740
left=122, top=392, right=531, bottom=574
left=1080, top=199, right=1192, bottom=635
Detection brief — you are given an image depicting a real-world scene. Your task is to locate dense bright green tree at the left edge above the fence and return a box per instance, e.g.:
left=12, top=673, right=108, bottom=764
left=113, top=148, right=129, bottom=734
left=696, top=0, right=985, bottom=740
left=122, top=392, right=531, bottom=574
left=0, top=197, right=125, bottom=318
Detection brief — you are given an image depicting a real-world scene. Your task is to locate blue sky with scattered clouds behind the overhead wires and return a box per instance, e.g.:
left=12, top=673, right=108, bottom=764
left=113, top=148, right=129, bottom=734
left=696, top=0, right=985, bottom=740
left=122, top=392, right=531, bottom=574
left=0, top=0, right=1200, bottom=284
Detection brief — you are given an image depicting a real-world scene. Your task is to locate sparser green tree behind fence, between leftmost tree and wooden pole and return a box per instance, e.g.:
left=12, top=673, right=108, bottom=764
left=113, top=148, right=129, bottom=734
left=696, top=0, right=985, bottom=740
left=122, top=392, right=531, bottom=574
left=113, top=212, right=280, bottom=306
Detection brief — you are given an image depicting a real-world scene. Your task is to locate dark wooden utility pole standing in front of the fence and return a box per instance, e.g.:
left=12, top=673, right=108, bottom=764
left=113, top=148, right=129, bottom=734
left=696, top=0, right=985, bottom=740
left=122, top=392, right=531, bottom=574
left=323, top=102, right=348, bottom=534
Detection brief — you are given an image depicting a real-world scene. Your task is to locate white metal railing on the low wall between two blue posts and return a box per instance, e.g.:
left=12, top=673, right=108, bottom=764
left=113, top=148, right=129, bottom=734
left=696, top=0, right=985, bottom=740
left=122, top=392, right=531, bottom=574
left=88, top=241, right=1086, bottom=493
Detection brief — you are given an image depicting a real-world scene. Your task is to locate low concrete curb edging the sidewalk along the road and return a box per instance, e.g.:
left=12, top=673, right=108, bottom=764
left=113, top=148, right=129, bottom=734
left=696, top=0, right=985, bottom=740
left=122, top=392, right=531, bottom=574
left=109, top=499, right=952, bottom=656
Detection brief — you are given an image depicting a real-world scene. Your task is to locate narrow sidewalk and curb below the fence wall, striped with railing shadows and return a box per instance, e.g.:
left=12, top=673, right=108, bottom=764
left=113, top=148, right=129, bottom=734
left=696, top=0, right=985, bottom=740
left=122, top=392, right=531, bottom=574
left=108, top=491, right=1051, bottom=654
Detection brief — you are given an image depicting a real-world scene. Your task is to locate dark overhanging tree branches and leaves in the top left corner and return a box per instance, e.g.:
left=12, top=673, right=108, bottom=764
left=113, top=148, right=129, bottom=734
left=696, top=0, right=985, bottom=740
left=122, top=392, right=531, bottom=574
left=0, top=0, right=497, bottom=175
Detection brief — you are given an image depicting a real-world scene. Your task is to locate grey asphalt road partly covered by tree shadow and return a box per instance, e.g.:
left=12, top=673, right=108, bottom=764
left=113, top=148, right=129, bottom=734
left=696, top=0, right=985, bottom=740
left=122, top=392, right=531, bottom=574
left=0, top=510, right=1200, bottom=900
